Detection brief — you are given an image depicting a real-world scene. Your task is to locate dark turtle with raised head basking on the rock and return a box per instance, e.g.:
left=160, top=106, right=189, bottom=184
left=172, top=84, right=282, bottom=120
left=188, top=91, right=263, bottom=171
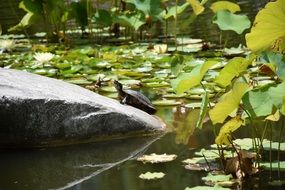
left=114, top=80, right=156, bottom=114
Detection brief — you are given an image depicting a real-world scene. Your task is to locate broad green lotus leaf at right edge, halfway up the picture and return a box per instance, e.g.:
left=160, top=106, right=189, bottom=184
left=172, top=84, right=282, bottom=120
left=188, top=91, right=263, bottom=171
left=242, top=82, right=285, bottom=117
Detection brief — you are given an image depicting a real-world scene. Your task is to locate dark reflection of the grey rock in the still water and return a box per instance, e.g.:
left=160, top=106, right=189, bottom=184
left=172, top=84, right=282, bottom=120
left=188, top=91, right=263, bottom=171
left=0, top=137, right=162, bottom=190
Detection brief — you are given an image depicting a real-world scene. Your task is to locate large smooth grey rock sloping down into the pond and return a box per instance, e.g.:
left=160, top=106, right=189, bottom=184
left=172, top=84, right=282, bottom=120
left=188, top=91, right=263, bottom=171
left=0, top=68, right=164, bottom=147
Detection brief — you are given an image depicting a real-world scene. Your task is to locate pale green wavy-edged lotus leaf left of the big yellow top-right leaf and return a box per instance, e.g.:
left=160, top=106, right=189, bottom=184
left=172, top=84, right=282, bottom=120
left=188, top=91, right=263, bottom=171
left=213, top=10, right=250, bottom=34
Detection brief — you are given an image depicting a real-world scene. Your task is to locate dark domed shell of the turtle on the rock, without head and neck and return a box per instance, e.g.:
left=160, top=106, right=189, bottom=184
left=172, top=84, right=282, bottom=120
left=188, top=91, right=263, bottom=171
left=124, top=90, right=156, bottom=114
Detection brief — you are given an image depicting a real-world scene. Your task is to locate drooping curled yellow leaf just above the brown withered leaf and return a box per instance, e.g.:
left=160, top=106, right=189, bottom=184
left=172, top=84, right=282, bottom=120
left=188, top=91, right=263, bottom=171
left=215, top=117, right=243, bottom=145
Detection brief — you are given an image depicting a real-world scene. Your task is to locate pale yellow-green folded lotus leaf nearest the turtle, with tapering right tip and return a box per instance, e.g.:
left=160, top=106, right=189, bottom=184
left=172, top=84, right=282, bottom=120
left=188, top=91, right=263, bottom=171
left=171, top=60, right=217, bottom=94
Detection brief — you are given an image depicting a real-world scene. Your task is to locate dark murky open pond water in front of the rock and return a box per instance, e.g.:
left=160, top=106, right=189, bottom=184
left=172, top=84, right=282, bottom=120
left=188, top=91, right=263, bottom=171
left=0, top=108, right=285, bottom=190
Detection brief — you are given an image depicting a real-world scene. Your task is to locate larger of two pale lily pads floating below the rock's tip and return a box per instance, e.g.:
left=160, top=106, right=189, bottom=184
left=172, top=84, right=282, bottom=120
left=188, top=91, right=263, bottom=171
left=137, top=153, right=177, bottom=164
